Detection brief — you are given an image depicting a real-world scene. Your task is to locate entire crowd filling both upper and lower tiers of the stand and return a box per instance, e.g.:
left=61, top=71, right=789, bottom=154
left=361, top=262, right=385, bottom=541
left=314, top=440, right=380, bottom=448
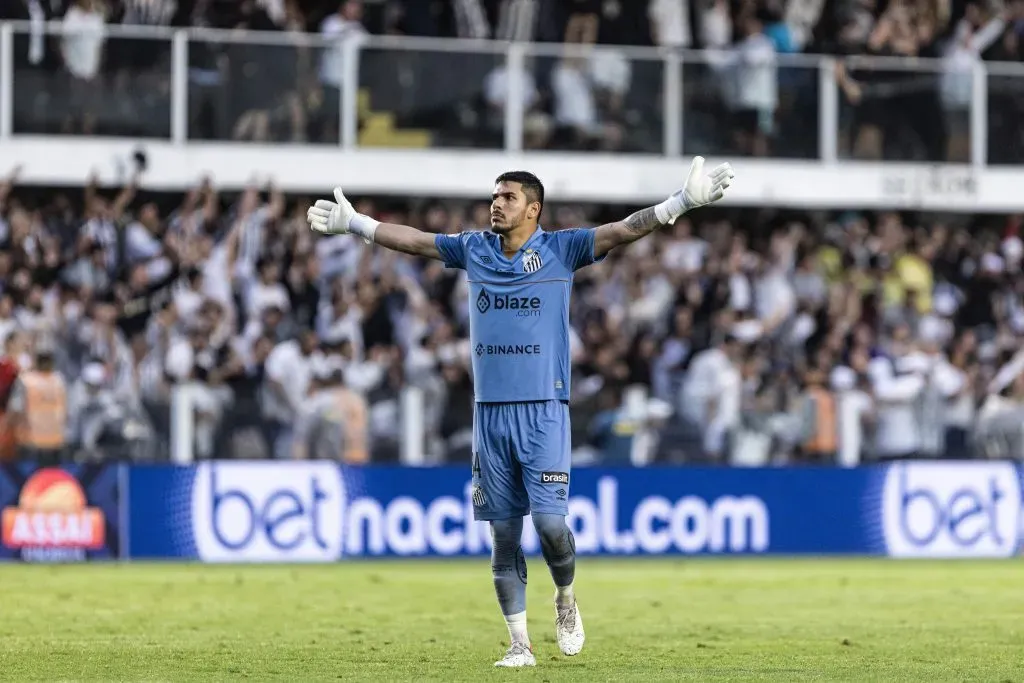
left=0, top=0, right=1024, bottom=465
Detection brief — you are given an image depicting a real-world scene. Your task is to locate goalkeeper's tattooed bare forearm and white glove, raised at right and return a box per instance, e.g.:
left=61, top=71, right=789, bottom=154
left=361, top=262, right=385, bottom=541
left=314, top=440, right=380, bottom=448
left=594, top=157, right=735, bottom=258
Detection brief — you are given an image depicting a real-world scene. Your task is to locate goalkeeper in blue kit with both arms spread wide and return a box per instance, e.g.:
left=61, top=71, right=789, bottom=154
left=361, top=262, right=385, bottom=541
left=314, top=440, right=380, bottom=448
left=307, top=157, right=734, bottom=667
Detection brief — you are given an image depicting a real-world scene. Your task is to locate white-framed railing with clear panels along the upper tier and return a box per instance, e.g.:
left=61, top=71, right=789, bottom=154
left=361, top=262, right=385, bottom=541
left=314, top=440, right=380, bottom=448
left=6, top=23, right=1024, bottom=167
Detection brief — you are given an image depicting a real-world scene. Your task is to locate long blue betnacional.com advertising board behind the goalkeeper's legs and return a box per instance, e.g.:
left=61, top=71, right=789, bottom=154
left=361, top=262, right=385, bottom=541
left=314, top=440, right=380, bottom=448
left=128, top=462, right=1022, bottom=562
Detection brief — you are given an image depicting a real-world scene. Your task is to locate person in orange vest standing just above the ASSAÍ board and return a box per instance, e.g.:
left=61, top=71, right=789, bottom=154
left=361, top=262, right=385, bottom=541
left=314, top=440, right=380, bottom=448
left=7, top=345, right=68, bottom=465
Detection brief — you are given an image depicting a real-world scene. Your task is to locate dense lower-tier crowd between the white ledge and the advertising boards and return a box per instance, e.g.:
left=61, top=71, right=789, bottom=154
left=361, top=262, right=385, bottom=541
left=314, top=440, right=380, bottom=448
left=0, top=164, right=1024, bottom=465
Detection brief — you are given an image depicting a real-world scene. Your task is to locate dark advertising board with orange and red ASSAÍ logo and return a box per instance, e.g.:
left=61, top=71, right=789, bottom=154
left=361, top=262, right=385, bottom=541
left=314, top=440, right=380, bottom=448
left=0, top=464, right=124, bottom=562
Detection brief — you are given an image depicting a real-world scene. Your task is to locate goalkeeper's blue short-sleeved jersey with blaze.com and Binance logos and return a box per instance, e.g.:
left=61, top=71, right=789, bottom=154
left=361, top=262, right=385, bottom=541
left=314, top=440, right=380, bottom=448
left=434, top=227, right=595, bottom=403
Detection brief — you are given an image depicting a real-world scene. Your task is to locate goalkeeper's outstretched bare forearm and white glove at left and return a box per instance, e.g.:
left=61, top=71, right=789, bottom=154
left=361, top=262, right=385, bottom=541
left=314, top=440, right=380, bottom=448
left=306, top=187, right=441, bottom=260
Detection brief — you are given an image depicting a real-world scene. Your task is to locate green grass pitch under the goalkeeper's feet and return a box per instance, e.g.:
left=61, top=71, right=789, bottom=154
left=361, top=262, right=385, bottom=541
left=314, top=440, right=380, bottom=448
left=0, top=558, right=1024, bottom=683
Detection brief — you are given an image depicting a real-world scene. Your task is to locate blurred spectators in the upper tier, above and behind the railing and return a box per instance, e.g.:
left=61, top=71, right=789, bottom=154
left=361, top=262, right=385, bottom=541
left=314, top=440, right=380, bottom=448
left=0, top=0, right=1024, bottom=163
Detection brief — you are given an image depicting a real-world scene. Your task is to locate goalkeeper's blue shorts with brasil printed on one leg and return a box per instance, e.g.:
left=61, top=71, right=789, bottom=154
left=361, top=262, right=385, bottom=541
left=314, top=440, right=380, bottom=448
left=473, top=400, right=571, bottom=521
